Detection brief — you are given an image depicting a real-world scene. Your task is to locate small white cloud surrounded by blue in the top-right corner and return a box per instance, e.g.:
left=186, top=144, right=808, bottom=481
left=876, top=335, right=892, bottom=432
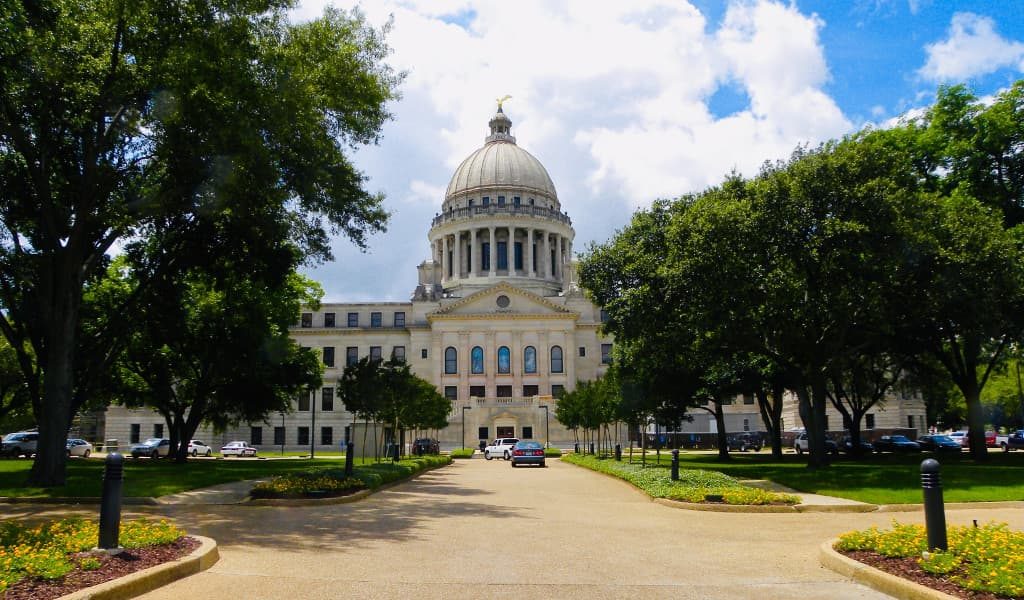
left=918, top=12, right=1024, bottom=82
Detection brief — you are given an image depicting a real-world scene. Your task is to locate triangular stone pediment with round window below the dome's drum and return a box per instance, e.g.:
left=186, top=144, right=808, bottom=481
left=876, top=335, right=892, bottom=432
left=427, top=283, right=580, bottom=319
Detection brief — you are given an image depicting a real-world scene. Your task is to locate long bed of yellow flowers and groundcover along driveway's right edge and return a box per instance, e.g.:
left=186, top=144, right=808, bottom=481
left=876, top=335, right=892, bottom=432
left=562, top=454, right=800, bottom=505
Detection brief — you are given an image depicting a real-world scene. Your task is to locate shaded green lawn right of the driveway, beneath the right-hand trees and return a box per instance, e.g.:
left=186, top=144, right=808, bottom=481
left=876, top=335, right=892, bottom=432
left=606, top=451, right=1024, bottom=504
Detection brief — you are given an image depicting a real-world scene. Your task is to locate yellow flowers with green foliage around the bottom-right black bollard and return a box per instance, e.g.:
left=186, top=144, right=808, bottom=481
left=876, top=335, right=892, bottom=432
left=836, top=521, right=1024, bottom=598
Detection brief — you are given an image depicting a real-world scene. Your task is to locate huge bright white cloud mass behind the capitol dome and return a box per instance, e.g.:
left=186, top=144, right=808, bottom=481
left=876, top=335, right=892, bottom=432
left=295, top=0, right=852, bottom=298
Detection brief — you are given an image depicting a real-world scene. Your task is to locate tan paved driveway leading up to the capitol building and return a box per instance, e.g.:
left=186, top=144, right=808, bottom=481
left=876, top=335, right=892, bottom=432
left=16, top=459, right=1024, bottom=600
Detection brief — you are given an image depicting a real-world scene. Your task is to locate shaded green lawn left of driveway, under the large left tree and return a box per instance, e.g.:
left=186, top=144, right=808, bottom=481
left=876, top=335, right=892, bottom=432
left=0, top=459, right=421, bottom=498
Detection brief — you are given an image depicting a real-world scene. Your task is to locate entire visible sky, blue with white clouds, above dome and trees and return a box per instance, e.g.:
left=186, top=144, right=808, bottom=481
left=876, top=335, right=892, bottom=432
left=292, top=0, right=1024, bottom=302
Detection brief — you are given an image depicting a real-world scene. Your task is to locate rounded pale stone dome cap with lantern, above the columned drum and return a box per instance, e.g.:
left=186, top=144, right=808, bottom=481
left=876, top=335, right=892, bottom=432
left=444, top=106, right=558, bottom=201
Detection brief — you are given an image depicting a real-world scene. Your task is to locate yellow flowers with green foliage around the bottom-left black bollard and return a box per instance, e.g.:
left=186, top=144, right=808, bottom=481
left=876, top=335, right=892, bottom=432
left=0, top=519, right=188, bottom=598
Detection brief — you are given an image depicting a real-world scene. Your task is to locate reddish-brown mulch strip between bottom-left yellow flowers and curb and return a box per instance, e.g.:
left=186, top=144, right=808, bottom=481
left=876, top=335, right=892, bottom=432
left=0, top=538, right=200, bottom=600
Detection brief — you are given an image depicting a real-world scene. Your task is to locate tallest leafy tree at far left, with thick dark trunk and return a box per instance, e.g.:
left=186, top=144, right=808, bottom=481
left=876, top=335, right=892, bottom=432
left=0, top=0, right=400, bottom=485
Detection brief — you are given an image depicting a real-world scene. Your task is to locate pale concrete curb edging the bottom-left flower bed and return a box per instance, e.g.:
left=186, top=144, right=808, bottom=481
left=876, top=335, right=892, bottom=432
left=59, top=535, right=220, bottom=600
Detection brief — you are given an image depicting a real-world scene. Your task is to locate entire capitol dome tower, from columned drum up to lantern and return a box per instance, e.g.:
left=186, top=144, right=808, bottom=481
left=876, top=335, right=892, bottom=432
left=428, top=106, right=575, bottom=297
